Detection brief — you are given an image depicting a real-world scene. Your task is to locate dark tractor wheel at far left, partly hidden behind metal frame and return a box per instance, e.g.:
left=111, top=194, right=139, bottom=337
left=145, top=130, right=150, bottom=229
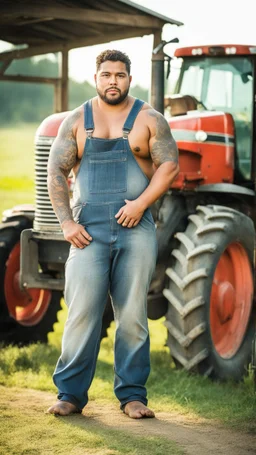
left=0, top=217, right=62, bottom=345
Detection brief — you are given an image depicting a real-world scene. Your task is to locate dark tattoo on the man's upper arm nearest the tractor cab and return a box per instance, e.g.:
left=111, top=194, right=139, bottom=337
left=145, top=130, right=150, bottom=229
left=149, top=110, right=178, bottom=167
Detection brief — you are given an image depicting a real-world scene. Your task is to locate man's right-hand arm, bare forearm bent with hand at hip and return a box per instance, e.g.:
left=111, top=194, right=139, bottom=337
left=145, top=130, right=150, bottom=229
left=116, top=109, right=179, bottom=228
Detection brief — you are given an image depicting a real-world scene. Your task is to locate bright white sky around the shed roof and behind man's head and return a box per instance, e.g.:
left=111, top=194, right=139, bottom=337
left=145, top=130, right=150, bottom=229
left=1, top=0, right=256, bottom=88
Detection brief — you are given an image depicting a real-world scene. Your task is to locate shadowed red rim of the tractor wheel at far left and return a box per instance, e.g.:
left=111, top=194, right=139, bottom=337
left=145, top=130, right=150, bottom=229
left=4, top=243, right=51, bottom=326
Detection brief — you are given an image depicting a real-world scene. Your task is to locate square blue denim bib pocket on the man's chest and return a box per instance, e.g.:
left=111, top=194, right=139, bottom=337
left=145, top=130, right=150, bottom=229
left=89, top=150, right=127, bottom=194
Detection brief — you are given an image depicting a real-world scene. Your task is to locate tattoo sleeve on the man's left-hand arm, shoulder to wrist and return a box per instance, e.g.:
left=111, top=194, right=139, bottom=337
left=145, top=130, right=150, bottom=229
left=48, top=112, right=81, bottom=224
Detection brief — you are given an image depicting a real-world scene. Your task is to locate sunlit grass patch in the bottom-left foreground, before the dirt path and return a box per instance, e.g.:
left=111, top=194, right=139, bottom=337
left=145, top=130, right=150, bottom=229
left=0, top=389, right=184, bottom=455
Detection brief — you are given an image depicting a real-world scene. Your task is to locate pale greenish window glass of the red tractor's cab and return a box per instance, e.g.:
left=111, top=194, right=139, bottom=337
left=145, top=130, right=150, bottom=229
left=177, top=56, right=253, bottom=181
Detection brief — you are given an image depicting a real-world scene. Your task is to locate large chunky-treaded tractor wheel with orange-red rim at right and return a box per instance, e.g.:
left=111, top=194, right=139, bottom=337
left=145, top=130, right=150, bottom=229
left=163, top=205, right=255, bottom=381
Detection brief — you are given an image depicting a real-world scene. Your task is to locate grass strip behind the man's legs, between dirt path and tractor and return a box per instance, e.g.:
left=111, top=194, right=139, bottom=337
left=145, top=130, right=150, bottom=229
left=0, top=309, right=256, bottom=431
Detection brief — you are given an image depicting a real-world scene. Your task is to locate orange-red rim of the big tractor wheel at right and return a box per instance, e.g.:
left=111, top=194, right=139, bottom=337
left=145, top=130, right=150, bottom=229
left=210, top=242, right=253, bottom=359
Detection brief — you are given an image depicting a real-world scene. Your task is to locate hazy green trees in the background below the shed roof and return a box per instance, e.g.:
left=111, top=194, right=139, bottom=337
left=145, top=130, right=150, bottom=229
left=0, top=58, right=148, bottom=126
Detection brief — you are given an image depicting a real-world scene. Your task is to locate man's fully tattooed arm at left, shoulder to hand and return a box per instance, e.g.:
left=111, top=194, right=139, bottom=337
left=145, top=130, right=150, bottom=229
left=47, top=110, right=92, bottom=248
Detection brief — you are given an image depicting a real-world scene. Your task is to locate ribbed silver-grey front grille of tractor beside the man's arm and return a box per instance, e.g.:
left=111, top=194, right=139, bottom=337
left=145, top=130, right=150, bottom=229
left=34, top=136, right=61, bottom=231
